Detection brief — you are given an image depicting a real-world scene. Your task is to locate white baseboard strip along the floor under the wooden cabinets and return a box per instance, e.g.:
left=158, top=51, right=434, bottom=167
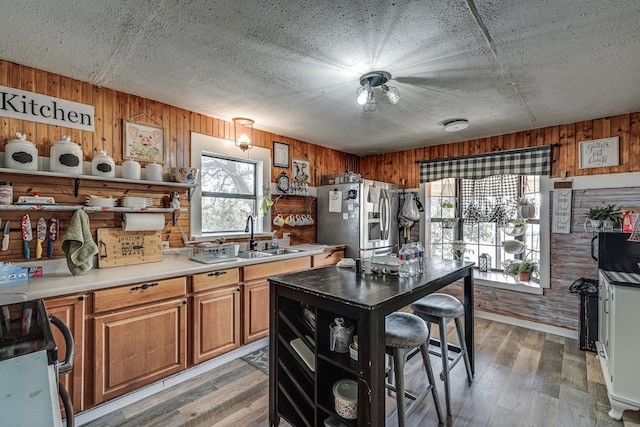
left=75, top=338, right=269, bottom=427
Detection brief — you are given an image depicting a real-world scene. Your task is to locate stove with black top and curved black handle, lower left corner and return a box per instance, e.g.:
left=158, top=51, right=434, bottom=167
left=0, top=300, right=74, bottom=427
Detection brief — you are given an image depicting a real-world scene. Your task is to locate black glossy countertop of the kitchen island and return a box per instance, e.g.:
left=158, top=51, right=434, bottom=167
left=269, top=258, right=473, bottom=310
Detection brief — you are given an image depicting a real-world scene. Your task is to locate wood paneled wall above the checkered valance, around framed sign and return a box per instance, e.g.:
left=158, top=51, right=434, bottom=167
left=360, top=112, right=640, bottom=188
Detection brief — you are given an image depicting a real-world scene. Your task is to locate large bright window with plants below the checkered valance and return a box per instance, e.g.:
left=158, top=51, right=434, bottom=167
left=426, top=175, right=541, bottom=282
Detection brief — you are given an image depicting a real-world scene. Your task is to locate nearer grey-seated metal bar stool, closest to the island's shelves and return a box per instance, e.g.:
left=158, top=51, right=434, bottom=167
left=385, top=312, right=444, bottom=427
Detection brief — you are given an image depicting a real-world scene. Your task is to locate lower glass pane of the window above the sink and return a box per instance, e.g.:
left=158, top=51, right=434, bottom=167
left=202, top=197, right=256, bottom=233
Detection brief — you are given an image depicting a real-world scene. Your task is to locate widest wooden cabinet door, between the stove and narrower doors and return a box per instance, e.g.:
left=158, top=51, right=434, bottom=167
left=93, top=297, right=187, bottom=404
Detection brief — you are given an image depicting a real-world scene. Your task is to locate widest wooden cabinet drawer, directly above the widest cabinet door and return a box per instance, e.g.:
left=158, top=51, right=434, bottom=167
left=93, top=277, right=187, bottom=313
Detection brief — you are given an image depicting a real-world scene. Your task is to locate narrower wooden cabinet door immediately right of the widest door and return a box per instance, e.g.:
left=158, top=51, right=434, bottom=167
left=192, top=285, right=240, bottom=365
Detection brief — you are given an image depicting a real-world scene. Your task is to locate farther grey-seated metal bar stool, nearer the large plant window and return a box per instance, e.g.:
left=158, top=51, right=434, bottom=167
left=411, top=293, right=473, bottom=415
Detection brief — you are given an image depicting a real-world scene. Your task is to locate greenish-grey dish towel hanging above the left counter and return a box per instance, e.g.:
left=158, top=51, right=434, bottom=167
left=62, top=209, right=98, bottom=276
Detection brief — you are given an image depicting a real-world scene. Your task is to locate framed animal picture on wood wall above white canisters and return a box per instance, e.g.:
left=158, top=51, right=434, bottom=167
left=122, top=119, right=164, bottom=163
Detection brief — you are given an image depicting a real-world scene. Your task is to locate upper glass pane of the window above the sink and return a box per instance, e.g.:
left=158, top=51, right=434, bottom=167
left=201, top=156, right=256, bottom=196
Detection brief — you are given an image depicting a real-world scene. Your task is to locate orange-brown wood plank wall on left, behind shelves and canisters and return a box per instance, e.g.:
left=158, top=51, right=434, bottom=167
left=0, top=60, right=359, bottom=261
